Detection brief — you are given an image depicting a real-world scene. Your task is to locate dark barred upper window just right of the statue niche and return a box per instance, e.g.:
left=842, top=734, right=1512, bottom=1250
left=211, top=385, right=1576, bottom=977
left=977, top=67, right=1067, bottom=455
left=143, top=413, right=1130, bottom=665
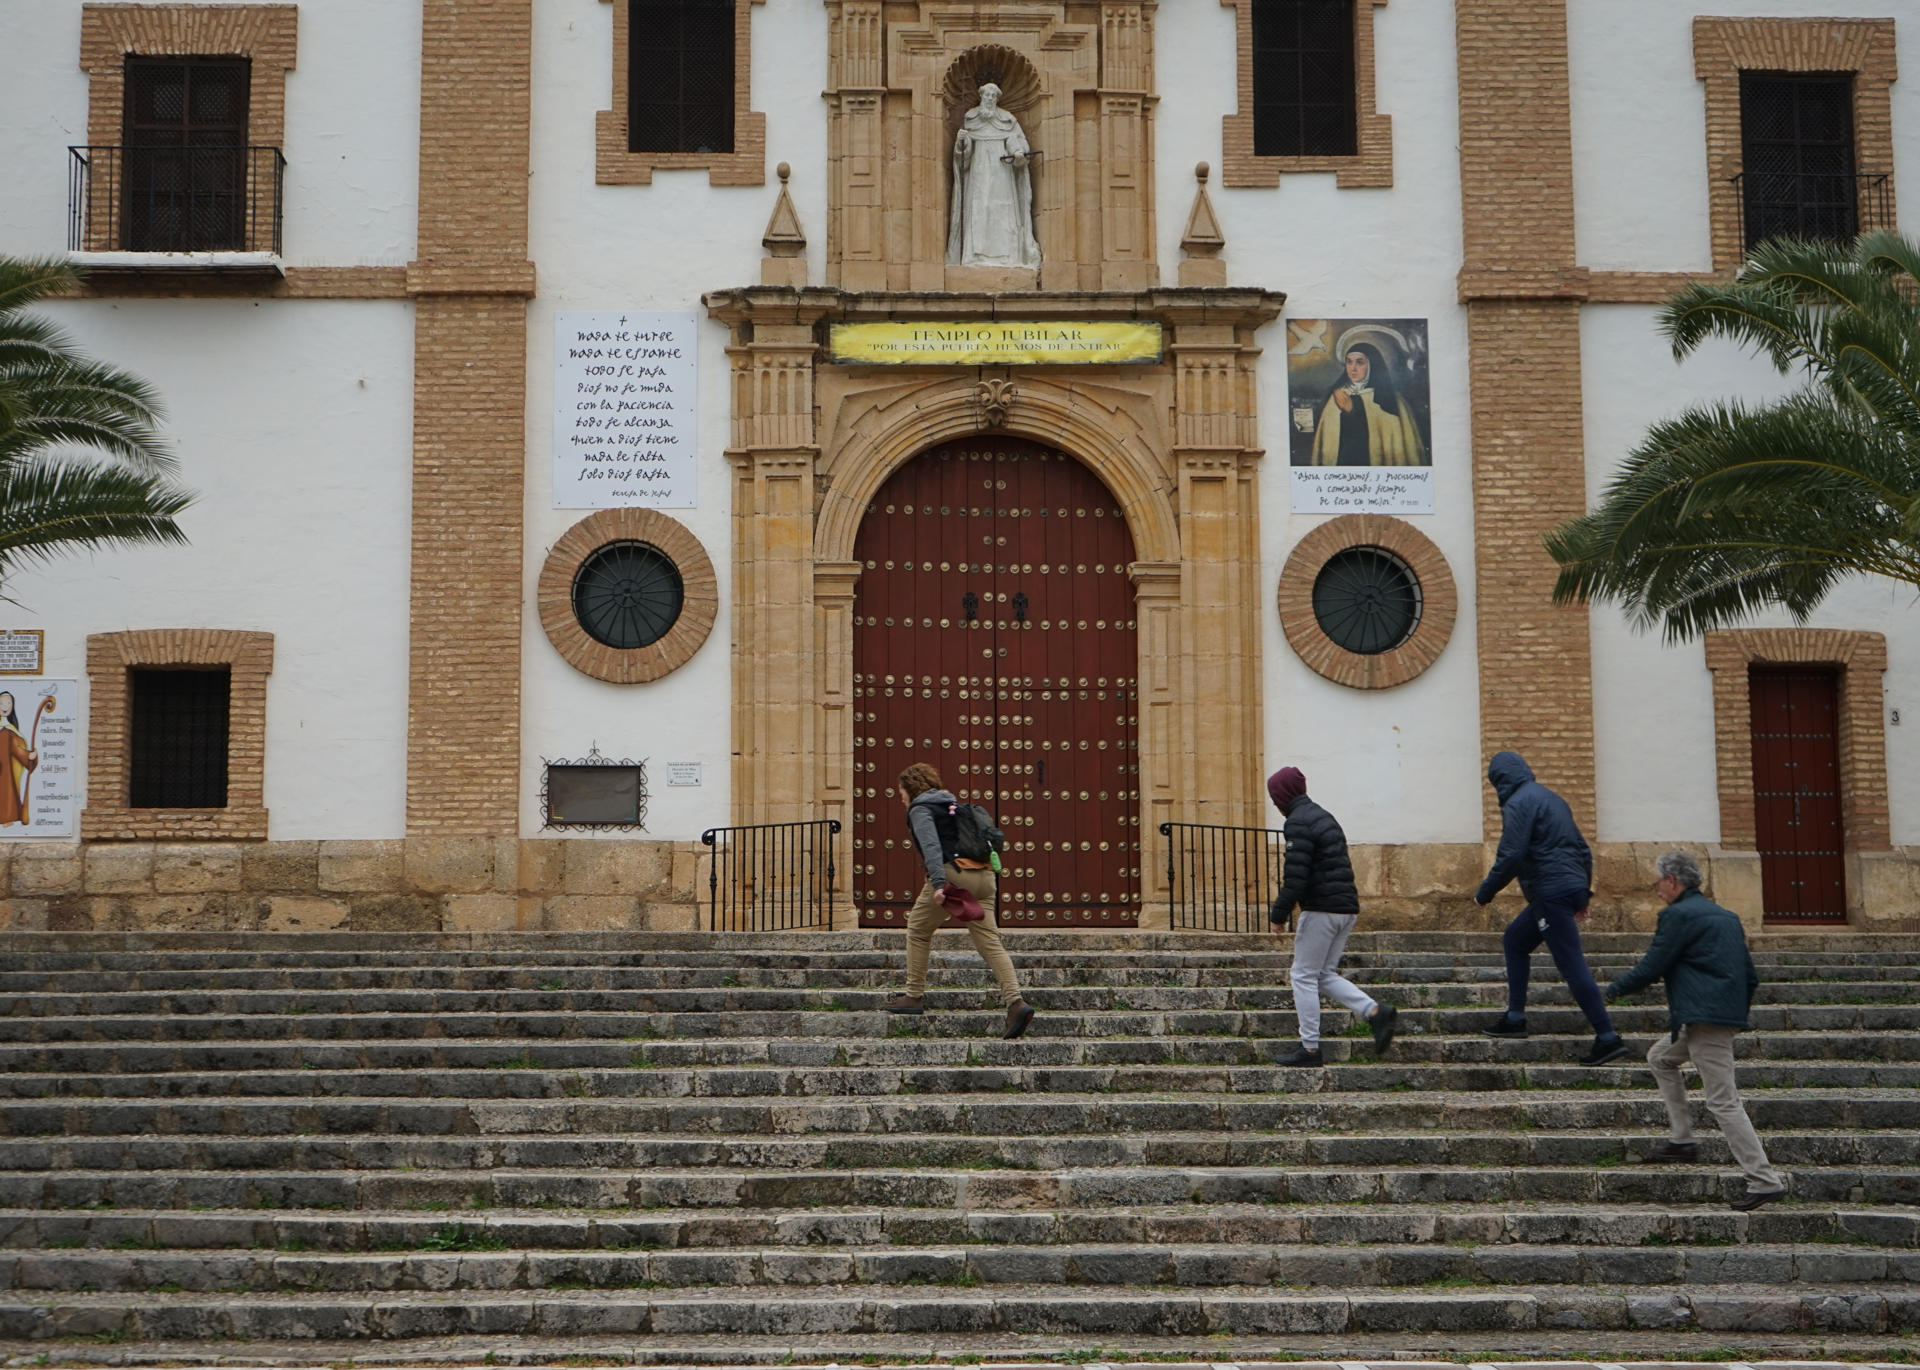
left=1254, top=0, right=1357, bottom=157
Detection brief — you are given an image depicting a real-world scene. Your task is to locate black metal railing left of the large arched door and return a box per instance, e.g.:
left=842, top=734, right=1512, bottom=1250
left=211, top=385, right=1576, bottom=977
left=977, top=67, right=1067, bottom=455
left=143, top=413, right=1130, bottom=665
left=701, top=817, right=841, bottom=933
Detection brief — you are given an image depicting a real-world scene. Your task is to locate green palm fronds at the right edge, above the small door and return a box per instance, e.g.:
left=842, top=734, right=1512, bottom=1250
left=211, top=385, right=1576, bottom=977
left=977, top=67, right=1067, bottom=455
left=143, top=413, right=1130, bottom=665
left=1546, top=232, right=1920, bottom=643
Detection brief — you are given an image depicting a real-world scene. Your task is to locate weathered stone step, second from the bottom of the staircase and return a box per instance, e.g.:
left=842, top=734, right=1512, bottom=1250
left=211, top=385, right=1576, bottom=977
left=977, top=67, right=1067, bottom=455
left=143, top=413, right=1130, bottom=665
left=0, top=1284, right=1920, bottom=1341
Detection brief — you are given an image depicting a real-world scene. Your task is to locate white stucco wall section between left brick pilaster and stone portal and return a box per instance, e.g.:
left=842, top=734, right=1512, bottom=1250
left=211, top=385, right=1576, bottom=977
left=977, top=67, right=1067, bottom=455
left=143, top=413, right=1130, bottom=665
left=520, top=0, right=828, bottom=840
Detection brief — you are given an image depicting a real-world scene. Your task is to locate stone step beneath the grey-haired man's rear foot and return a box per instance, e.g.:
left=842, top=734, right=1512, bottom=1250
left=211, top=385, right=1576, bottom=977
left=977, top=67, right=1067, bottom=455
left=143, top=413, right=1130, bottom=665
left=0, top=1199, right=1920, bottom=1251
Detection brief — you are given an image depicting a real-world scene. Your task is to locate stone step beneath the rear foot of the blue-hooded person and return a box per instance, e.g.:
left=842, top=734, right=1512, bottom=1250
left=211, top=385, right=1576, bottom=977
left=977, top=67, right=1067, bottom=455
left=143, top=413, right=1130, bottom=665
left=0, top=1042, right=1920, bottom=1103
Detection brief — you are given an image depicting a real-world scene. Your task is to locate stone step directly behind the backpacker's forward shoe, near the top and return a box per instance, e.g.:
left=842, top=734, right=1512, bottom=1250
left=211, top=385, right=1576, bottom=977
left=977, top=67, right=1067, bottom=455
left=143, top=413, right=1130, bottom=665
left=0, top=980, right=1916, bottom=1017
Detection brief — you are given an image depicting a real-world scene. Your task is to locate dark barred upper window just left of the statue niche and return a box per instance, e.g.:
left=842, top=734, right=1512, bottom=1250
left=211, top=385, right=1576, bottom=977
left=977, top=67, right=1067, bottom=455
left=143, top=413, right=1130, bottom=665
left=626, top=0, right=743, bottom=152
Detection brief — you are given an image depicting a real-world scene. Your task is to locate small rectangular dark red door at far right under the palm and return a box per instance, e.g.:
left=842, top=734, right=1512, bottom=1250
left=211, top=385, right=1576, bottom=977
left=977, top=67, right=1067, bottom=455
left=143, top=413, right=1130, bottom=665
left=1747, top=666, right=1847, bottom=923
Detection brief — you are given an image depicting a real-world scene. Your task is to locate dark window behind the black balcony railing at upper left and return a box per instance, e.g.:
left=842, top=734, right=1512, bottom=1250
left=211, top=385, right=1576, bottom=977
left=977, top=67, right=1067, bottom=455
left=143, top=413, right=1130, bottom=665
left=121, top=56, right=252, bottom=251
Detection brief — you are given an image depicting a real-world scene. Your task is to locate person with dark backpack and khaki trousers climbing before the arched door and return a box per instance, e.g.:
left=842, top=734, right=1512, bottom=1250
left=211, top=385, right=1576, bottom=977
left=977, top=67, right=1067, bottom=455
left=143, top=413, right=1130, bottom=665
left=885, top=762, right=1033, bottom=1040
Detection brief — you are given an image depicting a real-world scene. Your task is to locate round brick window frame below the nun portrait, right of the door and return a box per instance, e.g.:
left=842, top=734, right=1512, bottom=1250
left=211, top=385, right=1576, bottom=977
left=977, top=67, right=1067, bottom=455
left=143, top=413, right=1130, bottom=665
left=1279, top=514, right=1459, bottom=689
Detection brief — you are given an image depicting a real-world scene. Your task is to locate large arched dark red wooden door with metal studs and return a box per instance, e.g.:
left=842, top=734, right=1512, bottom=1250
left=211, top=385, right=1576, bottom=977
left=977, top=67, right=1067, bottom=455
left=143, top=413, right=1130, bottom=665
left=851, top=436, right=1142, bottom=927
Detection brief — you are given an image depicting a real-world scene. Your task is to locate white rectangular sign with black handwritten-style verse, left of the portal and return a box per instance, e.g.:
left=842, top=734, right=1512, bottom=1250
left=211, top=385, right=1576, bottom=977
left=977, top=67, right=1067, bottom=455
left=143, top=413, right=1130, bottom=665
left=553, top=309, right=697, bottom=508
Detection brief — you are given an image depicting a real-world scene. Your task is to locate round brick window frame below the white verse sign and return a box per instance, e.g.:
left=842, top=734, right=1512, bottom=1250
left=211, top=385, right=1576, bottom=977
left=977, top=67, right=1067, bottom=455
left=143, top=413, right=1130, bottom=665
left=536, top=508, right=720, bottom=685
